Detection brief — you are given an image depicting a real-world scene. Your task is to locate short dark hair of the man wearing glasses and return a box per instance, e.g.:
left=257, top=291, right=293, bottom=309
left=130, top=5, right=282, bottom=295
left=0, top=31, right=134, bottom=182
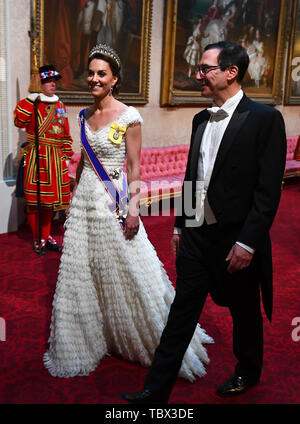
left=204, top=41, right=249, bottom=82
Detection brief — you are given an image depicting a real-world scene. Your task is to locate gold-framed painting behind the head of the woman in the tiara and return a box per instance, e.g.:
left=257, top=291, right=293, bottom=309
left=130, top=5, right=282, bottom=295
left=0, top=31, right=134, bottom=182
left=31, top=0, right=152, bottom=104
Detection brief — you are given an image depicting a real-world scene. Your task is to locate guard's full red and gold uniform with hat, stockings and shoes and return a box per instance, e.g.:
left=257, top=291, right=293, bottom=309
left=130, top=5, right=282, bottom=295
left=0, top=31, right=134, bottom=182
left=14, top=91, right=73, bottom=254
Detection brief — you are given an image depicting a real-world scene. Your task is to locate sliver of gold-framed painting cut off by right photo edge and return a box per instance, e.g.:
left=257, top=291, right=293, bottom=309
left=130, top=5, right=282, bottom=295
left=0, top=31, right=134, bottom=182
left=284, top=0, right=300, bottom=105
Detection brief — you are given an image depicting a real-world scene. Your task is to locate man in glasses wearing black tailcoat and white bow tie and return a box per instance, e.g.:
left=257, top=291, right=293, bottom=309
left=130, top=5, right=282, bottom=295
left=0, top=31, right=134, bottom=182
left=123, top=41, right=286, bottom=403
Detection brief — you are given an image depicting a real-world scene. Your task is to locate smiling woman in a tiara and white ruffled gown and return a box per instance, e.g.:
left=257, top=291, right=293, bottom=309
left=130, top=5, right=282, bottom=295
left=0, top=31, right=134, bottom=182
left=44, top=45, right=213, bottom=381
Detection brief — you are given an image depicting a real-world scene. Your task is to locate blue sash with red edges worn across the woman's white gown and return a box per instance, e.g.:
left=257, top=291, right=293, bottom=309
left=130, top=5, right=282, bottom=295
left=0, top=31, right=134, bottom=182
left=79, top=109, right=128, bottom=229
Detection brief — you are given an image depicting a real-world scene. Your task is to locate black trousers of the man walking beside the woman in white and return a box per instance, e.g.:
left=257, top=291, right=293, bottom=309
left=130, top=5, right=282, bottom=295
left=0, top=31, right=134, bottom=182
left=144, top=224, right=263, bottom=397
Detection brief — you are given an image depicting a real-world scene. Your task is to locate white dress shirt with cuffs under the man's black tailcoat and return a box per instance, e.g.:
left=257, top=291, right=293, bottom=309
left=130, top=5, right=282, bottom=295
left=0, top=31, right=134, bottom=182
left=174, top=90, right=255, bottom=254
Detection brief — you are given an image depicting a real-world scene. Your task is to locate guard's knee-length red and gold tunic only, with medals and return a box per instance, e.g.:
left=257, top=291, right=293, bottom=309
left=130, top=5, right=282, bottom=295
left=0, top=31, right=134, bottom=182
left=14, top=94, right=73, bottom=211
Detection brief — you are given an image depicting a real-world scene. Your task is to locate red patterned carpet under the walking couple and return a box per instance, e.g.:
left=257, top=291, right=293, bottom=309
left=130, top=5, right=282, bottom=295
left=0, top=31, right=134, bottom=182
left=0, top=182, right=300, bottom=405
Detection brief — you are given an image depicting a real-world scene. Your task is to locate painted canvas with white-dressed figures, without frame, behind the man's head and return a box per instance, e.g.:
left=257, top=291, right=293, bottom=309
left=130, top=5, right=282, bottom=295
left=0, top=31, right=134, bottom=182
left=173, top=0, right=281, bottom=94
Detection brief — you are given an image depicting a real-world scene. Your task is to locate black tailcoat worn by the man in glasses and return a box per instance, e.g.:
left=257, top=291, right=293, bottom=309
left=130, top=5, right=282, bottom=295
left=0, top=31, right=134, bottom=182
left=175, top=95, right=286, bottom=320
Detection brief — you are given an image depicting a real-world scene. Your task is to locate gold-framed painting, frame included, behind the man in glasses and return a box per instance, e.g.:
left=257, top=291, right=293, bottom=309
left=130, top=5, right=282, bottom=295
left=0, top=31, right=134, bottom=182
left=161, top=0, right=291, bottom=106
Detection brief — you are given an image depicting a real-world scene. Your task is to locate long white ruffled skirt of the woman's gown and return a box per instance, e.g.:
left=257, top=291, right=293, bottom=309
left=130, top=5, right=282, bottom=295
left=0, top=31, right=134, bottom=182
left=44, top=168, right=213, bottom=381
